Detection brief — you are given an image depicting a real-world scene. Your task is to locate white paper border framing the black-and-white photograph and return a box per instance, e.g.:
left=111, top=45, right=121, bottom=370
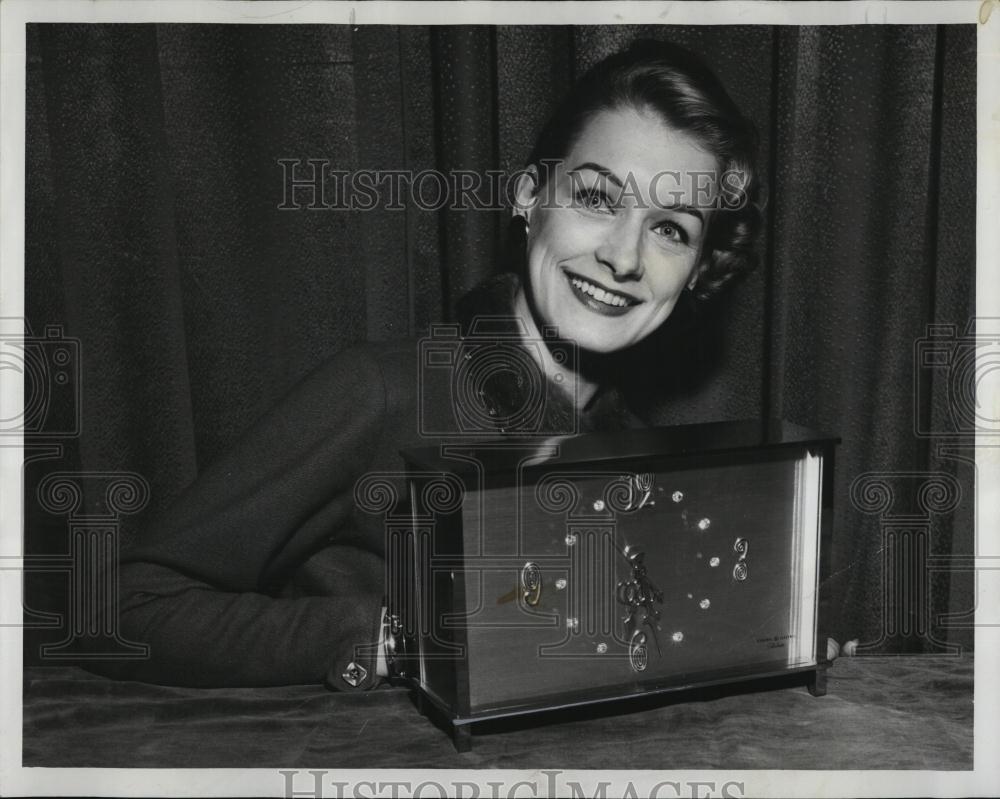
left=0, top=0, right=1000, bottom=797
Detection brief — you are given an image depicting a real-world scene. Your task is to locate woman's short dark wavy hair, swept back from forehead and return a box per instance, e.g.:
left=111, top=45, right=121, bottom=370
left=528, top=39, right=761, bottom=299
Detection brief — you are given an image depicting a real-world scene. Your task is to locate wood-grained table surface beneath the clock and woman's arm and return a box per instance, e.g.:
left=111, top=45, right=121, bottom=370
left=23, top=654, right=973, bottom=770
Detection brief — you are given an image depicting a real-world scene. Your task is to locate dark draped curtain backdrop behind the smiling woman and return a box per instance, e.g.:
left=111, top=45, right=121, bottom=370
left=25, top=24, right=976, bottom=660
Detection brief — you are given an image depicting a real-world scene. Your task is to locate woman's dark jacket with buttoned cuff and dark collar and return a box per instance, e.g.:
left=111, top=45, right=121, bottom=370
left=104, top=277, right=637, bottom=689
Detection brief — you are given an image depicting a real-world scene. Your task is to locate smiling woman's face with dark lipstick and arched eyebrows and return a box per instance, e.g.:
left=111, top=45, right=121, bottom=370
left=518, top=108, right=716, bottom=353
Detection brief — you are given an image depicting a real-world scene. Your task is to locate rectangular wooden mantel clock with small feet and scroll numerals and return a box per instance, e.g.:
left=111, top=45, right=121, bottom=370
left=387, top=420, right=838, bottom=749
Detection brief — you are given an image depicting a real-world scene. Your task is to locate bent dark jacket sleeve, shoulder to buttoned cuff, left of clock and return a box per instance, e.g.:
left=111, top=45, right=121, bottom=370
left=102, top=351, right=386, bottom=690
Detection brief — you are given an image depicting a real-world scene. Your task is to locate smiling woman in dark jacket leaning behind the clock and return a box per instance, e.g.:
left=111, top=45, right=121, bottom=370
left=103, top=42, right=758, bottom=690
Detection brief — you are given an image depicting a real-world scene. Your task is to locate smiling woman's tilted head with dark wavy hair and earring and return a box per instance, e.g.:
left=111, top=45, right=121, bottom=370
left=515, top=41, right=759, bottom=404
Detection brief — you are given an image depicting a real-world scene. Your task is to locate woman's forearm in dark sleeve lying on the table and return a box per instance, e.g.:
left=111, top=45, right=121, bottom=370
left=113, top=562, right=382, bottom=690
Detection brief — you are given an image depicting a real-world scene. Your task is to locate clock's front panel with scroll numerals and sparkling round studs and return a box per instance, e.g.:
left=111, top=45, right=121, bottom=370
left=462, top=451, right=821, bottom=704
